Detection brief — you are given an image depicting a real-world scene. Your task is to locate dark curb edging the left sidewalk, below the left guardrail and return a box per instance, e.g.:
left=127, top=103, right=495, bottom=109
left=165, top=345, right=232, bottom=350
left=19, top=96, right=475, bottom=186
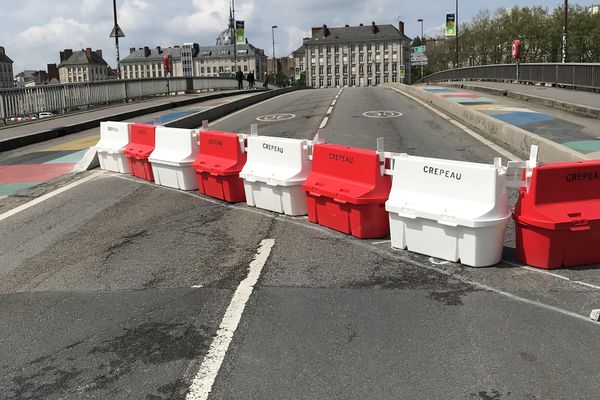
left=0, top=89, right=269, bottom=152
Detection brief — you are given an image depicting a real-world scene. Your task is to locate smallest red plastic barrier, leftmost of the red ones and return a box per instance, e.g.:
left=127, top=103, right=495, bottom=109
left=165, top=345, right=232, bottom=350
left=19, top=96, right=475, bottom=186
left=124, top=124, right=156, bottom=181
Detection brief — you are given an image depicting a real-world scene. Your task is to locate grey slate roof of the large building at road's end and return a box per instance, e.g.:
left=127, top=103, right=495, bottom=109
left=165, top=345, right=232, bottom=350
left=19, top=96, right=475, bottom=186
left=304, top=24, right=410, bottom=44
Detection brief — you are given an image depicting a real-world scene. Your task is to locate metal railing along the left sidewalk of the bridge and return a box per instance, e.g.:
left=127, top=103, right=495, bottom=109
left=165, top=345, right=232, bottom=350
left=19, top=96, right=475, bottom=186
left=0, top=77, right=262, bottom=119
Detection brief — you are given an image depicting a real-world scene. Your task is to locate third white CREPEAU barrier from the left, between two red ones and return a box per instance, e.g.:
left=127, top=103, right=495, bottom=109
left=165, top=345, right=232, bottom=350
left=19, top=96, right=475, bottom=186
left=240, top=136, right=312, bottom=215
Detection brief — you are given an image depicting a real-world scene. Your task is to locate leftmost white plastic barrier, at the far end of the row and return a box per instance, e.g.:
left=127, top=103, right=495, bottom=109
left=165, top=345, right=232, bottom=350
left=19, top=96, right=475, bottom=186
left=96, top=121, right=129, bottom=174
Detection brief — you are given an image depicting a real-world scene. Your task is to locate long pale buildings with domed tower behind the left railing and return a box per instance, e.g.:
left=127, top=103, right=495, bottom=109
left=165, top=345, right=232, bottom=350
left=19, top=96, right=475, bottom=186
left=121, top=25, right=267, bottom=79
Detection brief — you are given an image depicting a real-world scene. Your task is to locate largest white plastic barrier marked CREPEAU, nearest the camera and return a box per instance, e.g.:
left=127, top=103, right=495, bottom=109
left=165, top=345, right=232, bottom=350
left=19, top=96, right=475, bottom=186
left=385, top=154, right=510, bottom=267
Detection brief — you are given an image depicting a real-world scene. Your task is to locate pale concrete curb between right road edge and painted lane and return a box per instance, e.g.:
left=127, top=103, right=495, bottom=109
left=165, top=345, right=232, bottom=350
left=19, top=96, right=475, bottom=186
left=383, top=83, right=587, bottom=162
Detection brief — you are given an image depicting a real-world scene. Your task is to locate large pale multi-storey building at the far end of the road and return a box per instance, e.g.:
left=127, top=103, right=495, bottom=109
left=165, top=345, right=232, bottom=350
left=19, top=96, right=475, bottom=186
left=303, top=22, right=411, bottom=87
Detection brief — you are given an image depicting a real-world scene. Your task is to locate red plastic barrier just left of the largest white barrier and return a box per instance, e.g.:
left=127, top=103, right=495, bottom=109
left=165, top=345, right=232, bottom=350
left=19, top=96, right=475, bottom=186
left=302, top=144, right=391, bottom=239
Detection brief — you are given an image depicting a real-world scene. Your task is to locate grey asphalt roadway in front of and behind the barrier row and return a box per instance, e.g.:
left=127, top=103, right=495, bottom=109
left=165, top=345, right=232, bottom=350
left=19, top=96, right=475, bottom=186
left=0, top=88, right=600, bottom=400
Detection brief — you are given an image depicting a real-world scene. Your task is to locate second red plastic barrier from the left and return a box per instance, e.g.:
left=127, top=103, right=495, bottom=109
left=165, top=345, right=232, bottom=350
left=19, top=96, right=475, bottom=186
left=193, top=131, right=246, bottom=203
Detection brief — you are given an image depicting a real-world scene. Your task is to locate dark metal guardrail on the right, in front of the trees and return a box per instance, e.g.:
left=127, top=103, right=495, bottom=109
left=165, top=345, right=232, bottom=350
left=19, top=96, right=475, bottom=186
left=420, top=63, right=600, bottom=89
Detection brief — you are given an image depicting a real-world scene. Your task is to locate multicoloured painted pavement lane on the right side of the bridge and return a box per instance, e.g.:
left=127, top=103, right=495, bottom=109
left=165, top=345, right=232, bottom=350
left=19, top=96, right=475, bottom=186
left=423, top=87, right=600, bottom=157
